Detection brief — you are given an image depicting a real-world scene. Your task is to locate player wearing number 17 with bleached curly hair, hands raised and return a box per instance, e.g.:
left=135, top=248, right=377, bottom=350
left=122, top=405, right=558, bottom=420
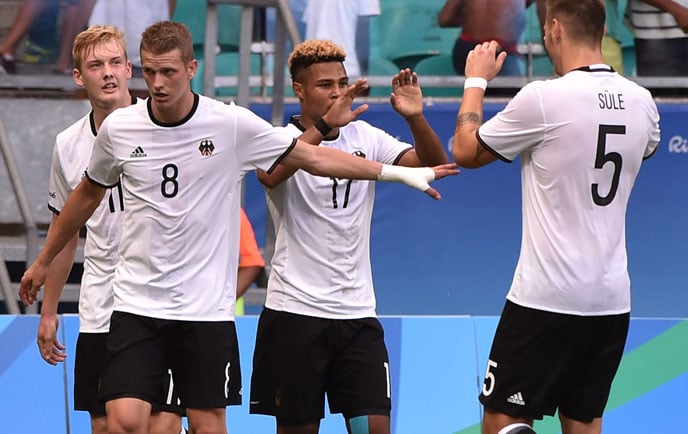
left=250, top=39, right=448, bottom=434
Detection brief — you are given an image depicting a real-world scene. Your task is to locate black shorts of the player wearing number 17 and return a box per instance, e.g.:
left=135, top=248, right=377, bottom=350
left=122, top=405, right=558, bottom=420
left=250, top=309, right=391, bottom=425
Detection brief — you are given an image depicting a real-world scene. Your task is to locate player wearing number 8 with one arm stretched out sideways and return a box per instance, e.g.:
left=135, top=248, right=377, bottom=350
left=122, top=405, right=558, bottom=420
left=21, top=21, right=458, bottom=433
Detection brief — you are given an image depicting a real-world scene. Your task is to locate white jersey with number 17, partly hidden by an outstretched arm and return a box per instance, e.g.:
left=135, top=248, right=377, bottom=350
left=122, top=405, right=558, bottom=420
left=265, top=121, right=411, bottom=319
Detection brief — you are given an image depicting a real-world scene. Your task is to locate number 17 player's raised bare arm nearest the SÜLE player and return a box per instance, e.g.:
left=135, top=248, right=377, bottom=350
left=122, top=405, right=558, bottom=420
left=389, top=68, right=449, bottom=167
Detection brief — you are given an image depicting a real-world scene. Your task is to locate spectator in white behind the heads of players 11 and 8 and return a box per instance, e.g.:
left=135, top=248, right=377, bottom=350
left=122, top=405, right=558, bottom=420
left=89, top=0, right=177, bottom=75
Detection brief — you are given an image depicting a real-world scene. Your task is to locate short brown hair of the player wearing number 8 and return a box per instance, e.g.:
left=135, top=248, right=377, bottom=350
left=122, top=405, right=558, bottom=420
left=140, top=21, right=194, bottom=63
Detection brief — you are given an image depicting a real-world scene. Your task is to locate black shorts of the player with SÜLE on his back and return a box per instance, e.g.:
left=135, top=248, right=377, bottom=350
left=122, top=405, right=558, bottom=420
left=479, top=301, right=630, bottom=422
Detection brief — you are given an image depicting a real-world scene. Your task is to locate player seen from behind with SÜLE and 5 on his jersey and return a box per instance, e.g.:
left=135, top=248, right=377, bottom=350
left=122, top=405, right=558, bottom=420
left=453, top=0, right=660, bottom=434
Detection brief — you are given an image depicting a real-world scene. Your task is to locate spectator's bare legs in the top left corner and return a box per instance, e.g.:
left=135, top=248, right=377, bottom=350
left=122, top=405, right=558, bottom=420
left=0, top=0, right=95, bottom=74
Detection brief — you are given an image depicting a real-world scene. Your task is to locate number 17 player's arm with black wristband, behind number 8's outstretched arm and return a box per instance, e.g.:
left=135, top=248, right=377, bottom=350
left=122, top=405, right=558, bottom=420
left=256, top=79, right=368, bottom=188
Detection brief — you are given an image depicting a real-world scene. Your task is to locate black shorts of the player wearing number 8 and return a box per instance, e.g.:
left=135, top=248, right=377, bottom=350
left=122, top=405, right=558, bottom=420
left=99, top=311, right=241, bottom=409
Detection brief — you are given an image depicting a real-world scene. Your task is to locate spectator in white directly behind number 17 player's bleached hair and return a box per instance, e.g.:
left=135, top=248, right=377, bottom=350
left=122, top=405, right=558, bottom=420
left=303, top=0, right=380, bottom=78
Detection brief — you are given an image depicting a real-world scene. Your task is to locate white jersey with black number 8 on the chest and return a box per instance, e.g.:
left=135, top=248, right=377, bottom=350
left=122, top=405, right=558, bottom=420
left=88, top=95, right=294, bottom=321
